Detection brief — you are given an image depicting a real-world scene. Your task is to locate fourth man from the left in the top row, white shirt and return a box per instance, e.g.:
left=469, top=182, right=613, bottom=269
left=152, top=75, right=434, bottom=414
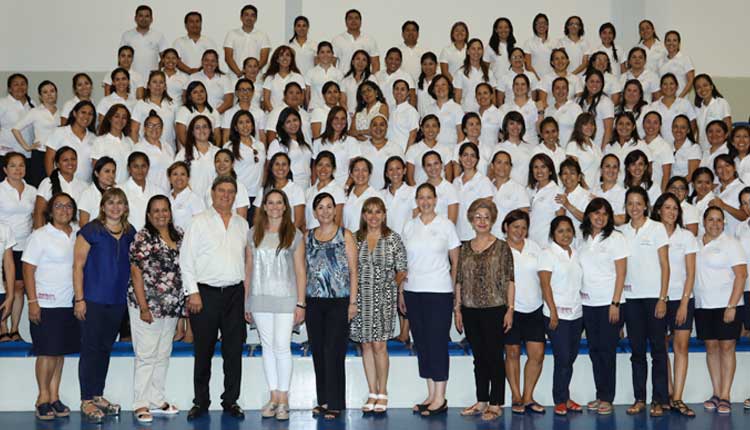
left=331, top=9, right=380, bottom=74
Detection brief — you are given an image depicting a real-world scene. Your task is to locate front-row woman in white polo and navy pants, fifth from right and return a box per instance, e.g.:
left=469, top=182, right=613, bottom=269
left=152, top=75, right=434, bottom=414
left=539, top=215, right=583, bottom=415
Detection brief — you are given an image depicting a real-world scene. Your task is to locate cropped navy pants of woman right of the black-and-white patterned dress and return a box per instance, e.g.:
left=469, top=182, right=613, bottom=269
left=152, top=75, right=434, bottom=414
left=404, top=291, right=453, bottom=382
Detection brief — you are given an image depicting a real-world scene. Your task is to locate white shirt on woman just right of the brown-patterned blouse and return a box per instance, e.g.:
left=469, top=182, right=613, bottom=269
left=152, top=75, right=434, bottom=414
left=510, top=239, right=543, bottom=314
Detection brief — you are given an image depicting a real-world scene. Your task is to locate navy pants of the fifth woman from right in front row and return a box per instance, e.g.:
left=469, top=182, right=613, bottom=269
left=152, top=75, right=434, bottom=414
left=544, top=317, right=583, bottom=405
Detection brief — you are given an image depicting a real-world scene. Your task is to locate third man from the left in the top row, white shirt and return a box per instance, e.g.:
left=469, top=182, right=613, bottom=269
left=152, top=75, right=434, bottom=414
left=224, top=4, right=271, bottom=77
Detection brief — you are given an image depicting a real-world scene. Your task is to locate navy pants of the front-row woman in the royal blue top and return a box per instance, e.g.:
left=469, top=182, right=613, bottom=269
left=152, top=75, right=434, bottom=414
left=78, top=302, right=127, bottom=400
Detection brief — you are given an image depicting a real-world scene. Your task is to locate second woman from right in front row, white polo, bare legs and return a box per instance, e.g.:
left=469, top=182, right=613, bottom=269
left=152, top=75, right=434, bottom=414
left=651, top=192, right=698, bottom=417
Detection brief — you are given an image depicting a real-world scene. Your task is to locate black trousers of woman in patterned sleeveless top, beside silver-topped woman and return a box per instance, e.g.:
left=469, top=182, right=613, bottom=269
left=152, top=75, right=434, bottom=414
left=305, top=297, right=349, bottom=411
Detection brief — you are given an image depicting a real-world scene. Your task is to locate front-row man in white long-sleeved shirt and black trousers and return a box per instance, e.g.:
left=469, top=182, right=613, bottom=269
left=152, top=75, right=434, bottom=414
left=180, top=176, right=249, bottom=421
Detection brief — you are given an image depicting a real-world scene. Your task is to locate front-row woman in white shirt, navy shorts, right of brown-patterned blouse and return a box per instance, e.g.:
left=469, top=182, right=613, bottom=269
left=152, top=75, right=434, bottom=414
left=503, top=209, right=549, bottom=414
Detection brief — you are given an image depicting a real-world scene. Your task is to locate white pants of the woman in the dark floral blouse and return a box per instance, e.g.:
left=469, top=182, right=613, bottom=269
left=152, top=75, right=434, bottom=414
left=128, top=306, right=177, bottom=410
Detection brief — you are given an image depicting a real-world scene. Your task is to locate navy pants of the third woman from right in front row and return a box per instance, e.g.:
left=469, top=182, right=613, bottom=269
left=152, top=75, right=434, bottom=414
left=625, top=299, right=669, bottom=404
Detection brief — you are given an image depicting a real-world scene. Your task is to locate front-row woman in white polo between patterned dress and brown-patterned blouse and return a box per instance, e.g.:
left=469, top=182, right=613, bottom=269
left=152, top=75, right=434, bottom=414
left=399, top=183, right=461, bottom=416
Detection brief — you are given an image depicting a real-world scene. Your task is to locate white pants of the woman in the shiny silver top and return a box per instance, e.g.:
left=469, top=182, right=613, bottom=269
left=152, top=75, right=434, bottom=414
left=253, top=312, right=294, bottom=391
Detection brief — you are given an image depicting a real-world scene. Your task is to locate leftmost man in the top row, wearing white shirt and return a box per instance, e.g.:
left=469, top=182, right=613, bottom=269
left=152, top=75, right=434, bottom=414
left=120, top=5, right=169, bottom=78
